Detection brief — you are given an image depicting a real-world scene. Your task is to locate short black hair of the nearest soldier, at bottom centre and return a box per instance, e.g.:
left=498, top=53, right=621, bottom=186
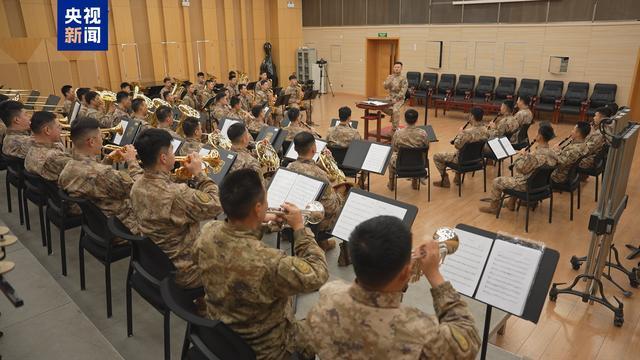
left=349, top=215, right=411, bottom=287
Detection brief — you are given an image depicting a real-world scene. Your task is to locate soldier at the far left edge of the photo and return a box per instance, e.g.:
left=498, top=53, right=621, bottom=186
left=0, top=100, right=33, bottom=159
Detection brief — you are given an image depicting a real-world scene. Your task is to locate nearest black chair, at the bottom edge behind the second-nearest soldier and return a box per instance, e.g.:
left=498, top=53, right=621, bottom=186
left=160, top=276, right=256, bottom=360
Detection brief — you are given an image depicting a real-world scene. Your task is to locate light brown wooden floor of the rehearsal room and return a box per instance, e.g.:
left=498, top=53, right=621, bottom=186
left=313, top=94, right=640, bottom=359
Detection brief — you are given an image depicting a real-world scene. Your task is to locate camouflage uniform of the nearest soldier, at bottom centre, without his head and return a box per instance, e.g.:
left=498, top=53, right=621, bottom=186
left=305, top=280, right=481, bottom=360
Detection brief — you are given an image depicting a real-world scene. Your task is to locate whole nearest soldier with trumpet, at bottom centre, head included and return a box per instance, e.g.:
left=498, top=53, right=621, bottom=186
left=304, top=216, right=481, bottom=360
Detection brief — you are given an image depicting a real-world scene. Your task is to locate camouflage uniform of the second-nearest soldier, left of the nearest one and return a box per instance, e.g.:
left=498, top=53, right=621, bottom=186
left=196, top=221, right=329, bottom=359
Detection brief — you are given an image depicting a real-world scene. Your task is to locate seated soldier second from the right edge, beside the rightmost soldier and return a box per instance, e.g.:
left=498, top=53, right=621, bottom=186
left=551, top=121, right=591, bottom=184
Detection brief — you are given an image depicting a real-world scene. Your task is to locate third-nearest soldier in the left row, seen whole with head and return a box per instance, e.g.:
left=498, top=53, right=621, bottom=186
left=131, top=129, right=222, bottom=288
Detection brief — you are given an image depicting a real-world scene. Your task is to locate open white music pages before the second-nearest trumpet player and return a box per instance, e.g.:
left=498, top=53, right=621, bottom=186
left=267, top=168, right=326, bottom=209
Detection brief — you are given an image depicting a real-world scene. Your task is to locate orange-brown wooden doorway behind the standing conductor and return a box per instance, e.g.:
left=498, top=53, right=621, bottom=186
left=365, top=38, right=400, bottom=98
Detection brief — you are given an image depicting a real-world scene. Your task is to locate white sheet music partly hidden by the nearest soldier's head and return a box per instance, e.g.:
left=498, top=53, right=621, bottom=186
left=332, top=192, right=407, bottom=240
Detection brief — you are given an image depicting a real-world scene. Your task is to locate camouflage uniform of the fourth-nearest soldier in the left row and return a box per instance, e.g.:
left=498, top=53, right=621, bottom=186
left=58, top=154, right=142, bottom=234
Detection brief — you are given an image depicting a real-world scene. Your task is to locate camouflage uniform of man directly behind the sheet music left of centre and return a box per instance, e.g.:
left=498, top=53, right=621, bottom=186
left=287, top=159, right=344, bottom=231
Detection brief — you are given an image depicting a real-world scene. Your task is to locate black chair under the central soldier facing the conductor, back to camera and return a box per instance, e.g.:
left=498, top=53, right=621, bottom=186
left=393, top=147, right=431, bottom=201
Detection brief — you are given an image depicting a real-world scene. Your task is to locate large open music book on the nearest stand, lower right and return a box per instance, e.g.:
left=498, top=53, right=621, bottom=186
left=440, top=228, right=544, bottom=316
